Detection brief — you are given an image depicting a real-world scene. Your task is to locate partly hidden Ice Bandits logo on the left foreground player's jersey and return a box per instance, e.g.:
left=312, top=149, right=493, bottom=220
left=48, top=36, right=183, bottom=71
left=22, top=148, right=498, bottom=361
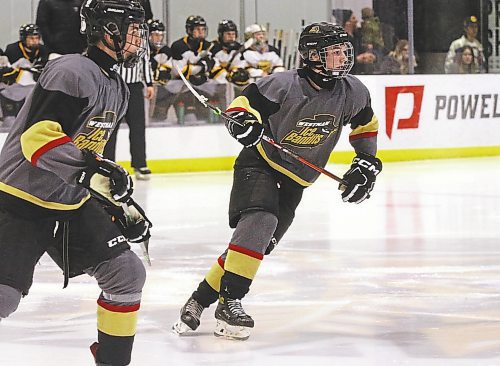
left=73, top=111, right=116, bottom=154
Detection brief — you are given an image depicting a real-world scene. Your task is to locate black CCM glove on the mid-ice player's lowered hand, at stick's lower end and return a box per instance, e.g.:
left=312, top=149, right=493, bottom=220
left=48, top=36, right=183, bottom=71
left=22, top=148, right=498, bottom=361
left=339, top=153, right=382, bottom=203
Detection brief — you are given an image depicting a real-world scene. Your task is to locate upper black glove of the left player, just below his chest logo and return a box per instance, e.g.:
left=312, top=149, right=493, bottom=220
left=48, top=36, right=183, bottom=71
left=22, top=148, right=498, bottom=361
left=77, top=149, right=134, bottom=202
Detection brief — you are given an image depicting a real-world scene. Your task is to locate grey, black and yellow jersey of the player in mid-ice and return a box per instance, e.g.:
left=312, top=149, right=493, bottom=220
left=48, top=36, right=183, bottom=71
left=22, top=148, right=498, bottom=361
left=227, top=69, right=378, bottom=186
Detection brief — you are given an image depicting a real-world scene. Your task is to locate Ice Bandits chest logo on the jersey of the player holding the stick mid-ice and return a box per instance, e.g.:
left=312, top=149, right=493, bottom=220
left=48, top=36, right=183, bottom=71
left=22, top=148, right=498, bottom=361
left=281, top=114, right=339, bottom=148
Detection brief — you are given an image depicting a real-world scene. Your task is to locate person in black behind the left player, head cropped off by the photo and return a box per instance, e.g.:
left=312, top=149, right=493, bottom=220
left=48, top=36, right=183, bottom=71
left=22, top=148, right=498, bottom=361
left=36, top=0, right=87, bottom=55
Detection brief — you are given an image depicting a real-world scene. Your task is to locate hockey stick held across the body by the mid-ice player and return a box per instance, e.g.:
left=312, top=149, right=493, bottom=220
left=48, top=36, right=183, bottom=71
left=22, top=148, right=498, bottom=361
left=176, top=66, right=347, bottom=189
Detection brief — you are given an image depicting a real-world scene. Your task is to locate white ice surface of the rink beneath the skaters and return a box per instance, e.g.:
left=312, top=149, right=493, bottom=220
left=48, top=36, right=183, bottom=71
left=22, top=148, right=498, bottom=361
left=0, top=157, right=500, bottom=366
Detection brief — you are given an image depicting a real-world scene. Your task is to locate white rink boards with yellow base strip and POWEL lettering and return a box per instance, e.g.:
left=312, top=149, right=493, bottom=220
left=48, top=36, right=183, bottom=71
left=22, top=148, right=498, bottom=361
left=0, top=74, right=500, bottom=172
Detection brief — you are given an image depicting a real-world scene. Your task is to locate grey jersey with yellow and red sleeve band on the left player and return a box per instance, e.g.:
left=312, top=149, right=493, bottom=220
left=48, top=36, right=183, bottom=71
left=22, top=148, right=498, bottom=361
left=0, top=48, right=129, bottom=214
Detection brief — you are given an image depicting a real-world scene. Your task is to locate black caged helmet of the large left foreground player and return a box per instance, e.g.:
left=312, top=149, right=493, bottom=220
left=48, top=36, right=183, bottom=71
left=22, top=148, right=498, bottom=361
left=80, top=0, right=148, bottom=67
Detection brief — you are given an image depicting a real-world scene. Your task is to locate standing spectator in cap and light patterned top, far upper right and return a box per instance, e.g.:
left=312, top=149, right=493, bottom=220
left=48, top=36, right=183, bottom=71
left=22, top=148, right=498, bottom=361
left=444, top=15, right=486, bottom=74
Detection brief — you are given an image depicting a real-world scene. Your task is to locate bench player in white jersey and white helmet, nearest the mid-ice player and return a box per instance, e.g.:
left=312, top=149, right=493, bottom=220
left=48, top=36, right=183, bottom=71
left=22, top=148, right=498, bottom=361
left=237, top=24, right=285, bottom=79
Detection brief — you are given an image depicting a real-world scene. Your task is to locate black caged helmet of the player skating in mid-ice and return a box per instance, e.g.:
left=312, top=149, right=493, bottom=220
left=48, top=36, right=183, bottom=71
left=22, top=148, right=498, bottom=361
left=299, top=22, right=354, bottom=79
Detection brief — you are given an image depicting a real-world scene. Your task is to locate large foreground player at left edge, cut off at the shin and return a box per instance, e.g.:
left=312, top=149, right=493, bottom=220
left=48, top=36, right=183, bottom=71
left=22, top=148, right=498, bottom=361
left=0, top=0, right=149, bottom=366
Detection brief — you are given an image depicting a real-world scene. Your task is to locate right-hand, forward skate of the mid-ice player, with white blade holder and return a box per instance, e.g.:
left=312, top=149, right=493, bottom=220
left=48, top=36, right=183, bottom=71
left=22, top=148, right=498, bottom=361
left=214, top=296, right=254, bottom=341
